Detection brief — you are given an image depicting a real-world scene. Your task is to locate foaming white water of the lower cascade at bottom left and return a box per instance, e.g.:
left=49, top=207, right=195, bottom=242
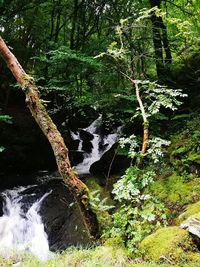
left=0, top=186, right=50, bottom=261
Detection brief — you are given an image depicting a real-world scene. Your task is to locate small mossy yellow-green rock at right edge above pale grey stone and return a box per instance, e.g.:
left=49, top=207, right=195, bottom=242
left=178, top=201, right=200, bottom=223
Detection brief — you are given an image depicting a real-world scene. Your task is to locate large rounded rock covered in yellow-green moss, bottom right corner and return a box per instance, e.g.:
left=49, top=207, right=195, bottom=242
left=140, top=226, right=200, bottom=264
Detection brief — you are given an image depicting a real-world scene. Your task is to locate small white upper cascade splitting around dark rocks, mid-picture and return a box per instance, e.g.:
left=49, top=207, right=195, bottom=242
left=71, top=115, right=121, bottom=175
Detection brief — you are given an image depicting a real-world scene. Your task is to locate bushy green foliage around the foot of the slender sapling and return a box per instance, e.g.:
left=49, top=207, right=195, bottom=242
left=110, top=167, right=166, bottom=253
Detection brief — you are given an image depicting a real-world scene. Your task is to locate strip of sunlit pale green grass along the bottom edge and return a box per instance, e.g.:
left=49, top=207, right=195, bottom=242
left=0, top=246, right=199, bottom=267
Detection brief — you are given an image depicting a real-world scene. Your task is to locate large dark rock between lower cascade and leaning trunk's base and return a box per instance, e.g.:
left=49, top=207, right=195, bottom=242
left=40, top=180, right=95, bottom=251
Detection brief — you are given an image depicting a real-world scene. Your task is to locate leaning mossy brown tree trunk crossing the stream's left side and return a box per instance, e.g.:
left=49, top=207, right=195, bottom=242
left=0, top=36, right=97, bottom=238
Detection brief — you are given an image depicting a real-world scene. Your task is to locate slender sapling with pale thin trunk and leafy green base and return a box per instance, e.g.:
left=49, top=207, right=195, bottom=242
left=96, top=13, right=186, bottom=253
